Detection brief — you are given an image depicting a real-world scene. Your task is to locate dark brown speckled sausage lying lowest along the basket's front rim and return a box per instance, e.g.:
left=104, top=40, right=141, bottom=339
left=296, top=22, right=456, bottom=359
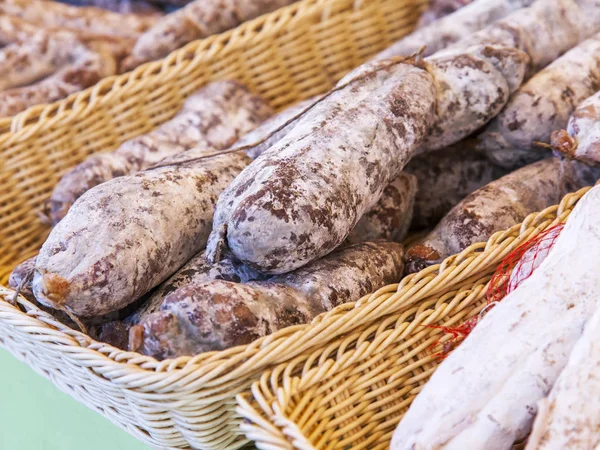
left=130, top=241, right=404, bottom=359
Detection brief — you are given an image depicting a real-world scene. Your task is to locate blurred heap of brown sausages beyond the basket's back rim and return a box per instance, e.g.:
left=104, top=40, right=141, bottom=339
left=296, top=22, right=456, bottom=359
left=0, top=0, right=295, bottom=117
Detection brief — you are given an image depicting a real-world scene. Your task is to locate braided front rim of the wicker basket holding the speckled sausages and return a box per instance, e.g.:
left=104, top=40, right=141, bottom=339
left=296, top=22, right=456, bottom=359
left=0, top=187, right=591, bottom=387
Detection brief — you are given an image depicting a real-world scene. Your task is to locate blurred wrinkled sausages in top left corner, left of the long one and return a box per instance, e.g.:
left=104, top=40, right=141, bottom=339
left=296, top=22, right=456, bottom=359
left=0, top=0, right=158, bottom=117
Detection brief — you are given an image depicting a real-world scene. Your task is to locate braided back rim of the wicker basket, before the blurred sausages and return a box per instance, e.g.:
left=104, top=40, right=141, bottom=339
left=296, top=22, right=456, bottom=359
left=0, top=0, right=336, bottom=142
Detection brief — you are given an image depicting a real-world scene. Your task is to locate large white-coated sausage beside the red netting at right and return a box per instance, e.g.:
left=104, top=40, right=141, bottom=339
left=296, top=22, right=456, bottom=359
left=391, top=187, right=600, bottom=450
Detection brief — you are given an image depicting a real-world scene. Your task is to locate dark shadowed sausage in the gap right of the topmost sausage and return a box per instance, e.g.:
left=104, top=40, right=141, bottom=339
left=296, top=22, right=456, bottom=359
left=404, top=141, right=508, bottom=230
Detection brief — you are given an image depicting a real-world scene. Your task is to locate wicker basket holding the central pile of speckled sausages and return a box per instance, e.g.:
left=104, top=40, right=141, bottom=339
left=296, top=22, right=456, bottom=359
left=0, top=0, right=432, bottom=449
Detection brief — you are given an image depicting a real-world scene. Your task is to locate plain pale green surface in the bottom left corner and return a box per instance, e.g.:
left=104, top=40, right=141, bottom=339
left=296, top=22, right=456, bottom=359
left=0, top=349, right=149, bottom=450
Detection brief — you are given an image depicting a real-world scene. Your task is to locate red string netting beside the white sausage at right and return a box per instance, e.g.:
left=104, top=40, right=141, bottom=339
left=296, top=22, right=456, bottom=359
left=426, top=223, right=564, bottom=360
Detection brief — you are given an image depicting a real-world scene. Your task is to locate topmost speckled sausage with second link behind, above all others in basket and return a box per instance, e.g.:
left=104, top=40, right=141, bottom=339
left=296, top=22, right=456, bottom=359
left=207, top=47, right=526, bottom=274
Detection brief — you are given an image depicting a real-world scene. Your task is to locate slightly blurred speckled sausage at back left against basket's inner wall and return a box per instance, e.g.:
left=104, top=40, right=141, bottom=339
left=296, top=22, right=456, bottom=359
left=48, top=81, right=272, bottom=224
